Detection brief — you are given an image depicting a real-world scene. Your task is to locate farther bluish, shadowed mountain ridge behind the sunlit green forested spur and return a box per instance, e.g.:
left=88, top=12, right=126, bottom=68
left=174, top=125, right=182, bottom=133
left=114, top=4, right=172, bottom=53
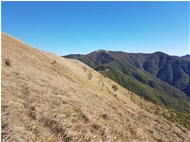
left=65, top=50, right=190, bottom=95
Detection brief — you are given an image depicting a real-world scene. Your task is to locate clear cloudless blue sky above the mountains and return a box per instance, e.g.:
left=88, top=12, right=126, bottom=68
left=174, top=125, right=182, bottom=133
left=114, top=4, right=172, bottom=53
left=2, top=2, right=190, bottom=56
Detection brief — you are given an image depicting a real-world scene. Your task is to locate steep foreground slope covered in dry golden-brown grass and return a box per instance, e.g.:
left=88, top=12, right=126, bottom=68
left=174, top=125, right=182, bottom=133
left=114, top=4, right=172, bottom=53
left=1, top=33, right=190, bottom=142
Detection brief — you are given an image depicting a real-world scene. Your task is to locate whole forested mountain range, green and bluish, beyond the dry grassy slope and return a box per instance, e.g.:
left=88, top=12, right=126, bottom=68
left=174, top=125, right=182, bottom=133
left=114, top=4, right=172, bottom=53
left=64, top=50, right=190, bottom=112
